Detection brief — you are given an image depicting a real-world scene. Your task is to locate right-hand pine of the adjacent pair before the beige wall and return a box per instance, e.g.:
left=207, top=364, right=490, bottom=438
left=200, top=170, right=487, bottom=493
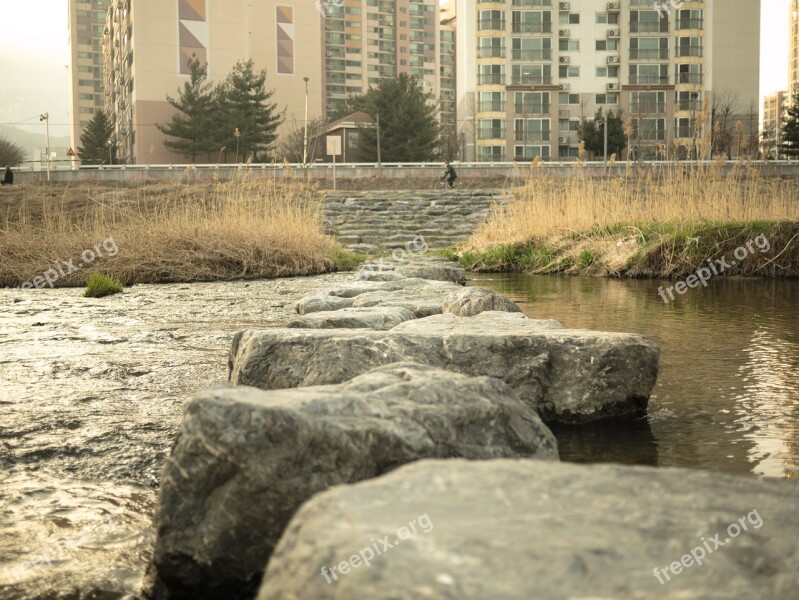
left=217, top=59, right=282, bottom=162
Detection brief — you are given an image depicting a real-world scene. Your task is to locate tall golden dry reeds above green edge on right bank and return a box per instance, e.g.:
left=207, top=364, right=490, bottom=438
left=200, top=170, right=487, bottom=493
left=464, top=162, right=799, bottom=251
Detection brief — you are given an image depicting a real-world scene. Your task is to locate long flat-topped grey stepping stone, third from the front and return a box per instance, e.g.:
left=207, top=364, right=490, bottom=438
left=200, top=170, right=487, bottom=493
left=229, top=312, right=660, bottom=423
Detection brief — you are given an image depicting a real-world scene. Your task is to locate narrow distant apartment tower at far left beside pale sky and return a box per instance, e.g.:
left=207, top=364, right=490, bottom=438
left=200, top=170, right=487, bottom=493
left=69, top=0, right=111, bottom=149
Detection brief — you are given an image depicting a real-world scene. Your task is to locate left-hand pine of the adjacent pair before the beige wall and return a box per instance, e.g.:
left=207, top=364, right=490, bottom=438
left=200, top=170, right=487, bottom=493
left=157, top=55, right=219, bottom=162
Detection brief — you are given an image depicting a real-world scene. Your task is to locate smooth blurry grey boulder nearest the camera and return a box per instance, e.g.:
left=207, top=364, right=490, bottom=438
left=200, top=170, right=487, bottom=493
left=258, top=460, right=799, bottom=600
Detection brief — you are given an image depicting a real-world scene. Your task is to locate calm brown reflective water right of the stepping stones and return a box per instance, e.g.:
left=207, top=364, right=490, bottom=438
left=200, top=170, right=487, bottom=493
left=470, top=274, right=799, bottom=478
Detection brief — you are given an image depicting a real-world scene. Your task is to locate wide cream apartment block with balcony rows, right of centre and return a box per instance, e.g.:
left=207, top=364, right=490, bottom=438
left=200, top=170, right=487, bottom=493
left=457, top=0, right=760, bottom=161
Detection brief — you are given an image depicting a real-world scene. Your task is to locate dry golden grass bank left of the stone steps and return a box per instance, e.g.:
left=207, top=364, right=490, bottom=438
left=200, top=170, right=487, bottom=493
left=0, top=177, right=358, bottom=287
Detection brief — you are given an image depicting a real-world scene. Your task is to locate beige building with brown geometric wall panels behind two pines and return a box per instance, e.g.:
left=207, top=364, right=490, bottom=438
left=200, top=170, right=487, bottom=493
left=103, top=0, right=323, bottom=164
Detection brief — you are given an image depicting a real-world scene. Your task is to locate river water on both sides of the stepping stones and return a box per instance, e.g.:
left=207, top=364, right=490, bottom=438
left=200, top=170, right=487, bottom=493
left=0, top=274, right=799, bottom=600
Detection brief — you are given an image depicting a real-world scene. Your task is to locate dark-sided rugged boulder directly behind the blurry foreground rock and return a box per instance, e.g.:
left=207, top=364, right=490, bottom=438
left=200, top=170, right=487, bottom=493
left=153, top=364, right=557, bottom=599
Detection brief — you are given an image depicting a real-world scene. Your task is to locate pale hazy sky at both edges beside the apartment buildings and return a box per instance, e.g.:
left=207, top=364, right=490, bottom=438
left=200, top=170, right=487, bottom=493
left=0, top=0, right=789, bottom=141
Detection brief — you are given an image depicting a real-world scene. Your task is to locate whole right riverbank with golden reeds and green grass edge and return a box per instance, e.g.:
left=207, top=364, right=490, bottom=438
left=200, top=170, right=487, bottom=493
left=456, top=165, right=799, bottom=278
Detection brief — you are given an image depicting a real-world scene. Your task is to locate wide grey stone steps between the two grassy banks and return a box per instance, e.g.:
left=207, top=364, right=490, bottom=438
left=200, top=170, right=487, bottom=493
left=322, top=190, right=505, bottom=255
